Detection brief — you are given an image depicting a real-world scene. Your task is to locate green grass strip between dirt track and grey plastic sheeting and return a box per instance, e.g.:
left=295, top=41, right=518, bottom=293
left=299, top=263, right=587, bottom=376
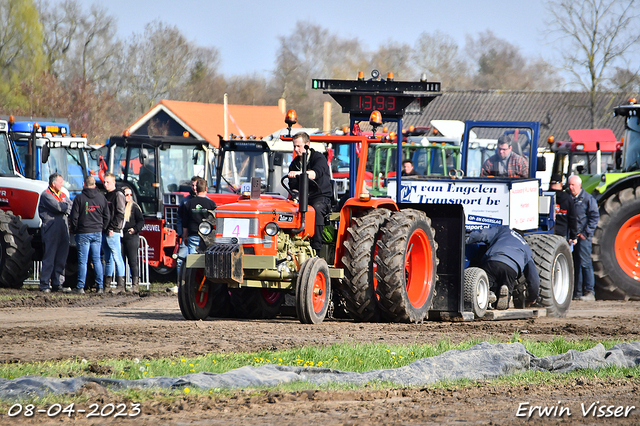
left=0, top=335, right=632, bottom=380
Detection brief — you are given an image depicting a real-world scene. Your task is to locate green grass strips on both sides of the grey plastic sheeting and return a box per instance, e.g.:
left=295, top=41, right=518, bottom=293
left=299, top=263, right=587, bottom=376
left=0, top=333, right=640, bottom=413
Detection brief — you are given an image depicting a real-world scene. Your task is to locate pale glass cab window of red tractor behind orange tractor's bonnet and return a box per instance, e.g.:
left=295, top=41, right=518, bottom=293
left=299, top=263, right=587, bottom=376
left=160, top=145, right=207, bottom=193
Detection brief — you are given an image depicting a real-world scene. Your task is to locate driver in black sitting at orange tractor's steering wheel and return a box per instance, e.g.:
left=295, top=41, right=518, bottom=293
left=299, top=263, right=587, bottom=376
left=288, top=132, right=332, bottom=253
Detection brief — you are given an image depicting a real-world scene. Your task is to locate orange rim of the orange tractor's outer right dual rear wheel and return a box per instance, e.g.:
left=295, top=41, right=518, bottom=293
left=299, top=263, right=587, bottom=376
left=404, top=229, right=433, bottom=308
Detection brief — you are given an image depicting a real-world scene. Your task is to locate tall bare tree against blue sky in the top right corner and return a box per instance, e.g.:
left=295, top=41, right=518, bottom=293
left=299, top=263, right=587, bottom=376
left=547, top=0, right=640, bottom=128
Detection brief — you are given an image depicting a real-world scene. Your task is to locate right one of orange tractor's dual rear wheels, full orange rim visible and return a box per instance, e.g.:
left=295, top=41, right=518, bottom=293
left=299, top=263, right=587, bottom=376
left=376, top=209, right=438, bottom=322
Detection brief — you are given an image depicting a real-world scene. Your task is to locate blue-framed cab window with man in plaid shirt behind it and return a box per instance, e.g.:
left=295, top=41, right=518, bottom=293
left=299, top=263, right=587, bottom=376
left=466, top=127, right=533, bottom=178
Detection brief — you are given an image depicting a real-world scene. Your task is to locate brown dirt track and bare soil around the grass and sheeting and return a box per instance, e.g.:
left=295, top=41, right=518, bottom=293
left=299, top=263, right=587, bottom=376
left=0, top=290, right=640, bottom=425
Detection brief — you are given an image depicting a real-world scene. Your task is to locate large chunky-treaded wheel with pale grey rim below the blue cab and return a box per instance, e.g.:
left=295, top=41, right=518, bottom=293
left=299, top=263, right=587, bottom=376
left=525, top=234, right=574, bottom=318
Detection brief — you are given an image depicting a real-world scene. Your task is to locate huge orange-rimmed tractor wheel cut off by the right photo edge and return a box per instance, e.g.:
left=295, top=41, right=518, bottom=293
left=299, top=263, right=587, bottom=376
left=592, top=188, right=640, bottom=300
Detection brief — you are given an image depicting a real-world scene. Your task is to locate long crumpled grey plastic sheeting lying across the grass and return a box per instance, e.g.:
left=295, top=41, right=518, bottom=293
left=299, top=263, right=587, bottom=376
left=0, top=342, right=640, bottom=399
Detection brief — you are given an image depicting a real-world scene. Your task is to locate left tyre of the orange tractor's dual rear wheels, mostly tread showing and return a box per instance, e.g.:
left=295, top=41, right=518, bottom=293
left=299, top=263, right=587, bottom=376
left=342, top=209, right=391, bottom=321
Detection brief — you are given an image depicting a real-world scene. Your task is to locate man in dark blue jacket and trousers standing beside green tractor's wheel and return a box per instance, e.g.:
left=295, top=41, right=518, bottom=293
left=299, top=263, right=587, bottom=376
left=569, top=175, right=600, bottom=301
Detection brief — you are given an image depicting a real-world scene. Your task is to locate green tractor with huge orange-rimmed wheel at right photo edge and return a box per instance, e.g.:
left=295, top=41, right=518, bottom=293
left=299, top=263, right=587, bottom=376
left=583, top=99, right=640, bottom=300
